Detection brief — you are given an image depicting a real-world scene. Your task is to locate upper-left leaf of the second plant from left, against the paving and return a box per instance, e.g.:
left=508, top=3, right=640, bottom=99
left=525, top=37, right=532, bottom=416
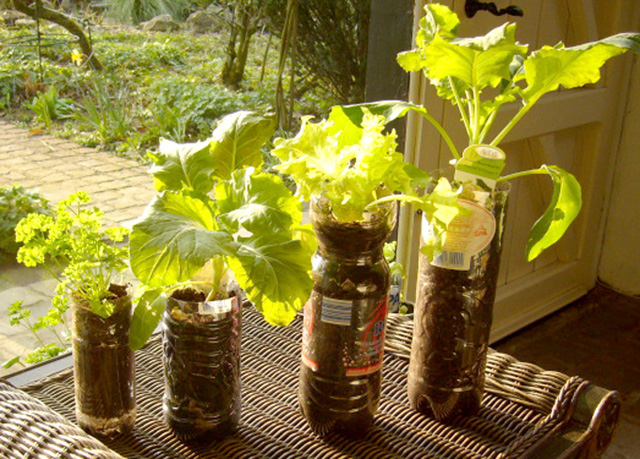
left=148, top=139, right=215, bottom=193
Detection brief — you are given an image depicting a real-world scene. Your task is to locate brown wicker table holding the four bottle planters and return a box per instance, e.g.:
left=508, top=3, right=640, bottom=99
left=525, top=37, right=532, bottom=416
left=0, top=308, right=619, bottom=459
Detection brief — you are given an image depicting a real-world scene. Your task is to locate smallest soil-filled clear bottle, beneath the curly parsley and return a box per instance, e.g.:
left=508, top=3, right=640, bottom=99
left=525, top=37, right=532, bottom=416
left=72, top=284, right=136, bottom=437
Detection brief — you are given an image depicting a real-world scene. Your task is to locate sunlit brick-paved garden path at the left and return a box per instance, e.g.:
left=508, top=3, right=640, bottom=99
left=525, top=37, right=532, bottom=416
left=0, top=119, right=154, bottom=377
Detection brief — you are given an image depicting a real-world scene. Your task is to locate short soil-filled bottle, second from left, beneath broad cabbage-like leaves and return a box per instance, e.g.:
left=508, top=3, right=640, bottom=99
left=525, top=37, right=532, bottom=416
left=162, top=290, right=241, bottom=441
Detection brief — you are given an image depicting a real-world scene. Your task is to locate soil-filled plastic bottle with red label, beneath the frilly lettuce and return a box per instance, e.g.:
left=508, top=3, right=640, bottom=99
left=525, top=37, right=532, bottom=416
left=299, top=199, right=396, bottom=436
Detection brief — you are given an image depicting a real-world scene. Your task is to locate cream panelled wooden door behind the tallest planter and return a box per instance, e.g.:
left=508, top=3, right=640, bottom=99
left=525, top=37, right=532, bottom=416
left=399, top=0, right=640, bottom=340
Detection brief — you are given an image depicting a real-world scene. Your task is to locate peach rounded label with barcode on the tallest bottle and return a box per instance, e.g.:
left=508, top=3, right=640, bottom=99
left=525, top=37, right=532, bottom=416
left=422, top=199, right=496, bottom=271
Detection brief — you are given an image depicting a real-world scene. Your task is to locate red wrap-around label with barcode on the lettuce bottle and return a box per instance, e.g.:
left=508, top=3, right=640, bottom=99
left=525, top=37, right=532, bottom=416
left=302, top=292, right=389, bottom=376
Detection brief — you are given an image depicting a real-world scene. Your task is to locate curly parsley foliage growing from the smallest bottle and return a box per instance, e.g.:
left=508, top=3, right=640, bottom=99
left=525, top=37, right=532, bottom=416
left=16, top=192, right=128, bottom=317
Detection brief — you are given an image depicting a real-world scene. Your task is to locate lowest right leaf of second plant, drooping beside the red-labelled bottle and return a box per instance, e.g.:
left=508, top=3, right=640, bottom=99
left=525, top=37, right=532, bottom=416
left=229, top=235, right=313, bottom=325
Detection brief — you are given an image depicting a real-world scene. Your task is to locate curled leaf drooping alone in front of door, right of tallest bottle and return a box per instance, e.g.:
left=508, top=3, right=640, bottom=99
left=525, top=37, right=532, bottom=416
left=525, top=166, right=582, bottom=261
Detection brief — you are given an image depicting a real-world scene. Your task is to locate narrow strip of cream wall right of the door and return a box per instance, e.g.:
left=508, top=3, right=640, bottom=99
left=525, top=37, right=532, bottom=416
left=598, top=57, right=640, bottom=295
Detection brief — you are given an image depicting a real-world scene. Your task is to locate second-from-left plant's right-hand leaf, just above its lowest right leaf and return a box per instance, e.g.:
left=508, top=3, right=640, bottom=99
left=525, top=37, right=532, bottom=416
left=215, top=169, right=302, bottom=234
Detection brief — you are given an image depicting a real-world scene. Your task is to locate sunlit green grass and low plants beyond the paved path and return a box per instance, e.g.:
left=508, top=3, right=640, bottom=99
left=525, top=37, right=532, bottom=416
left=0, top=22, right=333, bottom=158
